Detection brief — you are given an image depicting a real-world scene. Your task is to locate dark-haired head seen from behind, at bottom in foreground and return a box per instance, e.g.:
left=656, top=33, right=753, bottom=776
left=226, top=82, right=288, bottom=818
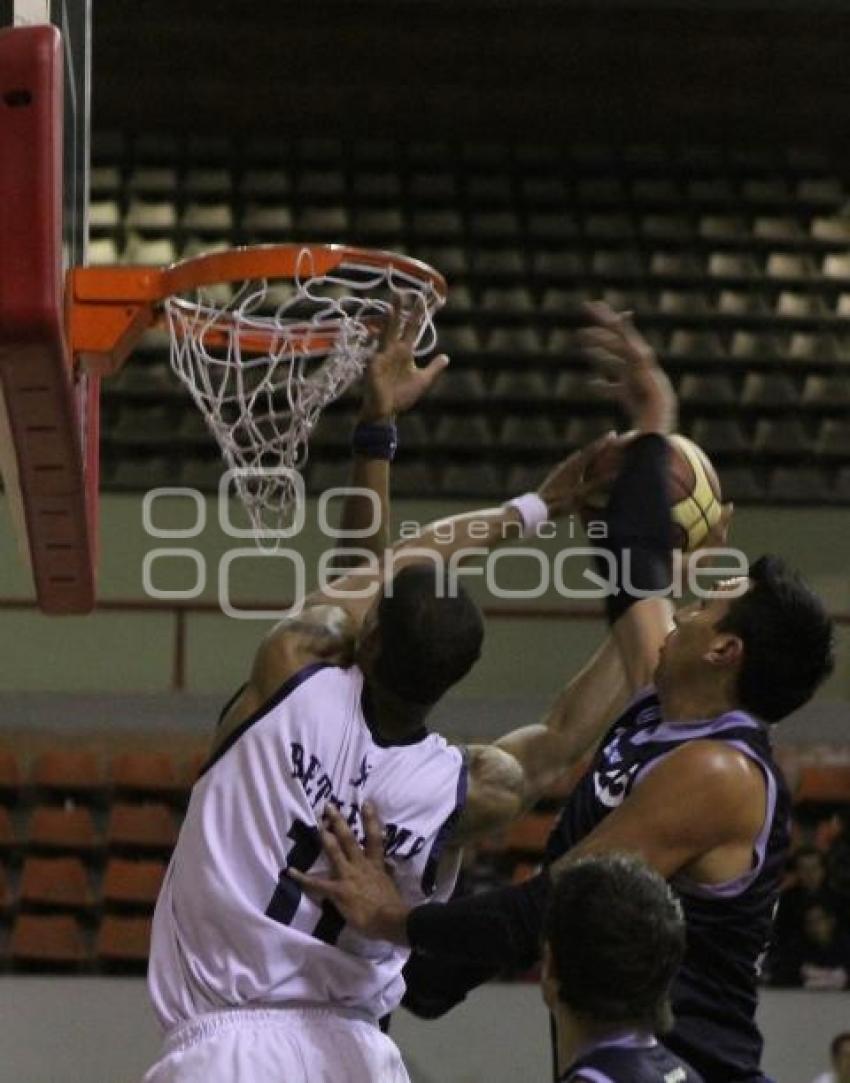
left=542, top=854, right=684, bottom=1032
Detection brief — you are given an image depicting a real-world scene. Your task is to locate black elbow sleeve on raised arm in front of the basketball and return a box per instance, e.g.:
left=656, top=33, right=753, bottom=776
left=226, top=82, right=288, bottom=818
left=593, top=433, right=672, bottom=625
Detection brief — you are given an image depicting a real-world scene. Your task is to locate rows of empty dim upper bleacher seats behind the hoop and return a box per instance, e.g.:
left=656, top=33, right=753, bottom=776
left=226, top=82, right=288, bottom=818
left=91, top=133, right=850, bottom=504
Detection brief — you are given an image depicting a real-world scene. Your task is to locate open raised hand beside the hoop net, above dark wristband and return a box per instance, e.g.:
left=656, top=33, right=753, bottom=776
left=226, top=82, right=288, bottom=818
left=362, top=298, right=448, bottom=421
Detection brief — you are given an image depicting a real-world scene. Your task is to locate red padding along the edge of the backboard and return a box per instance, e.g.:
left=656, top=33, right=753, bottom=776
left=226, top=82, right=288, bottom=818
left=0, top=26, right=97, bottom=613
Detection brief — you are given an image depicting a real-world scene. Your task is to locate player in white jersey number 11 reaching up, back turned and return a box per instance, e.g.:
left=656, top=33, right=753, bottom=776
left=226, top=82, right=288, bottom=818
left=145, top=313, right=622, bottom=1083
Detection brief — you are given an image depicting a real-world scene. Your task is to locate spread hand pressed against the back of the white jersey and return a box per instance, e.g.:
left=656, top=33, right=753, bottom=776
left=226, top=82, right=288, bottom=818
left=287, top=803, right=408, bottom=944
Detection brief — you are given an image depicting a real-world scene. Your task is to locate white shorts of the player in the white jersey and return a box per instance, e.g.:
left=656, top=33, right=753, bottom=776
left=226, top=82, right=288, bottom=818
left=143, top=1008, right=409, bottom=1083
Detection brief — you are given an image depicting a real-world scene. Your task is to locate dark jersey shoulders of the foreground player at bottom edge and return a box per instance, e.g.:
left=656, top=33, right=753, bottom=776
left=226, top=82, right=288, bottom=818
left=561, top=1035, right=704, bottom=1083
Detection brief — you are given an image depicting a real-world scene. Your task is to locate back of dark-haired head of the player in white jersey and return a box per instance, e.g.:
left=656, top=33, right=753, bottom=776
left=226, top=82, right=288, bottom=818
left=357, top=562, right=484, bottom=706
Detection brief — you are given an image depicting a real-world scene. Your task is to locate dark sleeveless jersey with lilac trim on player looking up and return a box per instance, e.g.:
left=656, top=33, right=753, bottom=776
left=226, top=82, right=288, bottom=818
left=547, top=689, right=790, bottom=1083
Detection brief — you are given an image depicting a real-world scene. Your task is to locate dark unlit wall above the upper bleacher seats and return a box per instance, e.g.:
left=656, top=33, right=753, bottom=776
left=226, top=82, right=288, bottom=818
left=93, top=0, right=850, bottom=149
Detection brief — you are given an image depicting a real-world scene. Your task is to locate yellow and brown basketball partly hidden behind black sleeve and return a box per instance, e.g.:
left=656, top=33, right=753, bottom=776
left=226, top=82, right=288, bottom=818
left=583, top=433, right=722, bottom=552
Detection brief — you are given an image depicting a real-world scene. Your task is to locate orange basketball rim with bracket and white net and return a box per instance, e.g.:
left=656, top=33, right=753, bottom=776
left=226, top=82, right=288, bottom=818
left=68, top=245, right=446, bottom=539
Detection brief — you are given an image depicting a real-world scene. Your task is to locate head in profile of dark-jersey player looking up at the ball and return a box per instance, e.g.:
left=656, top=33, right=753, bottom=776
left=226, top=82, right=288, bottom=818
left=655, top=557, right=834, bottom=722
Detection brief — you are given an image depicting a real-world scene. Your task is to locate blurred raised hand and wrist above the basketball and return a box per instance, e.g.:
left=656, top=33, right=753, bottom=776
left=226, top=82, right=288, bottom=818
left=578, top=301, right=677, bottom=434
